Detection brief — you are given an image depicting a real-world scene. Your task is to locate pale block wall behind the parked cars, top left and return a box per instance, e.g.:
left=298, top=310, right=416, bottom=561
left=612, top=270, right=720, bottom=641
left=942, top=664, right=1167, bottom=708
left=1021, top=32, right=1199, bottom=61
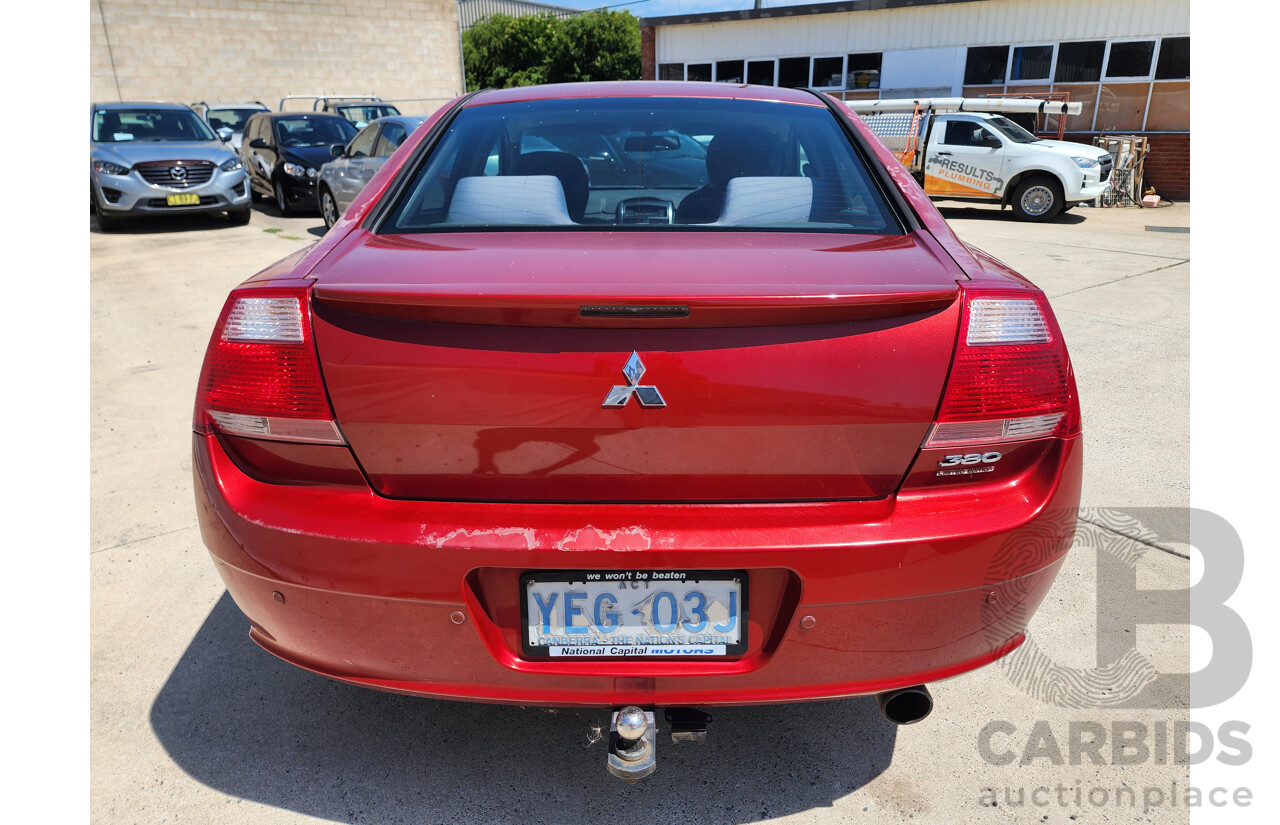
left=90, top=0, right=462, bottom=114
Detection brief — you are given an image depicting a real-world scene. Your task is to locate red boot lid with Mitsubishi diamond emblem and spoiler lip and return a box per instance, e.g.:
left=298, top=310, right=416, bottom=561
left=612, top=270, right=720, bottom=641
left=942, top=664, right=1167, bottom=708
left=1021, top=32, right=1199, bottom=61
left=312, top=232, right=964, bottom=503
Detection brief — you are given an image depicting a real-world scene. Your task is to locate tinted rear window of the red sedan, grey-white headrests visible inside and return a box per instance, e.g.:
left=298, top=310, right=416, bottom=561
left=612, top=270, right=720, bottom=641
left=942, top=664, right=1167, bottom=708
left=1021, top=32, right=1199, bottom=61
left=380, top=97, right=902, bottom=234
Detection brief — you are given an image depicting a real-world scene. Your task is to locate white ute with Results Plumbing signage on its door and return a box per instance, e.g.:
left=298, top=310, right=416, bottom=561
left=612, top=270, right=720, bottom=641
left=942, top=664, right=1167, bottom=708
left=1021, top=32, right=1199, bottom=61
left=846, top=97, right=1112, bottom=220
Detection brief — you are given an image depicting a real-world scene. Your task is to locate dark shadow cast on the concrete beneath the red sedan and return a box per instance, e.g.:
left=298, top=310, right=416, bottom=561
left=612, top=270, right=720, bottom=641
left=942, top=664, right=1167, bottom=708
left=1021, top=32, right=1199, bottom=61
left=151, top=593, right=896, bottom=824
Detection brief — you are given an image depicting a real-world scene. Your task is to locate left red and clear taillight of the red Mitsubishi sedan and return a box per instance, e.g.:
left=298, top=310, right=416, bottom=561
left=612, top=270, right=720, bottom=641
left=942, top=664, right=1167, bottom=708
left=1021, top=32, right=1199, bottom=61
left=186, top=289, right=346, bottom=444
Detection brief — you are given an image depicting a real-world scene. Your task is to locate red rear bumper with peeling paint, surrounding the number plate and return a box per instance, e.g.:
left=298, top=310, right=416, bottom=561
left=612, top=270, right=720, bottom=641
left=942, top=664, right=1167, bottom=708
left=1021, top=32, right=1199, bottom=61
left=193, top=435, right=1082, bottom=706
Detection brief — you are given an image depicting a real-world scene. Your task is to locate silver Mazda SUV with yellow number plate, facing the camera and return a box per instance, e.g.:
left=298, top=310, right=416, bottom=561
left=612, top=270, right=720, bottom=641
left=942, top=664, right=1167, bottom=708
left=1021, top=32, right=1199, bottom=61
left=90, top=104, right=251, bottom=232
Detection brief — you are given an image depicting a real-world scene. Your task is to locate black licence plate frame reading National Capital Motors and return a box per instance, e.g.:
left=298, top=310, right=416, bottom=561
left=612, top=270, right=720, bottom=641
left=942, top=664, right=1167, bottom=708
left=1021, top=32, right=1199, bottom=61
left=518, top=568, right=750, bottom=661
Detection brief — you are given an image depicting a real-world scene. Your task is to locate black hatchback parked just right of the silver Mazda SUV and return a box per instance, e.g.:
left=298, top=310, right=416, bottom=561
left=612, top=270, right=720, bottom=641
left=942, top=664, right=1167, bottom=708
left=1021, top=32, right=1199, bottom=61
left=241, top=113, right=356, bottom=215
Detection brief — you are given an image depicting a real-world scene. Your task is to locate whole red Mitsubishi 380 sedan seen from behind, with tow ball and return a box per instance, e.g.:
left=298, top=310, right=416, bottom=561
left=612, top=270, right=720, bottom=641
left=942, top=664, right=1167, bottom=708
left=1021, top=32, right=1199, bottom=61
left=193, top=83, right=1082, bottom=778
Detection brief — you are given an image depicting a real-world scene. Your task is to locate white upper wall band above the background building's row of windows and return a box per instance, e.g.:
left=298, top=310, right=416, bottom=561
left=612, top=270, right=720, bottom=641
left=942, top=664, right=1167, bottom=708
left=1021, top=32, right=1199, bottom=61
left=660, top=0, right=1190, bottom=63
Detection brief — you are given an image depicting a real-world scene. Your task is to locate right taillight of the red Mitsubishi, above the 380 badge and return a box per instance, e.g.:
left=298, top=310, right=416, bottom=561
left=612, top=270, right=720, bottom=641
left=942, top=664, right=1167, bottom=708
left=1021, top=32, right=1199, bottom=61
left=924, top=287, right=1080, bottom=448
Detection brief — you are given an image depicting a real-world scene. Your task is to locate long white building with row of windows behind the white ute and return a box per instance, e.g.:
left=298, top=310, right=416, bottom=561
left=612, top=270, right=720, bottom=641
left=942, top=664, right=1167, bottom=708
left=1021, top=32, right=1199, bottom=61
left=640, top=0, right=1190, bottom=200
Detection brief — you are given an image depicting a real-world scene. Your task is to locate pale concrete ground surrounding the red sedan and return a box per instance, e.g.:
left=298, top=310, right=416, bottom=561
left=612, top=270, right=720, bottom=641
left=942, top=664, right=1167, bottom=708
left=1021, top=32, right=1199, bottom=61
left=90, top=199, right=1190, bottom=824
